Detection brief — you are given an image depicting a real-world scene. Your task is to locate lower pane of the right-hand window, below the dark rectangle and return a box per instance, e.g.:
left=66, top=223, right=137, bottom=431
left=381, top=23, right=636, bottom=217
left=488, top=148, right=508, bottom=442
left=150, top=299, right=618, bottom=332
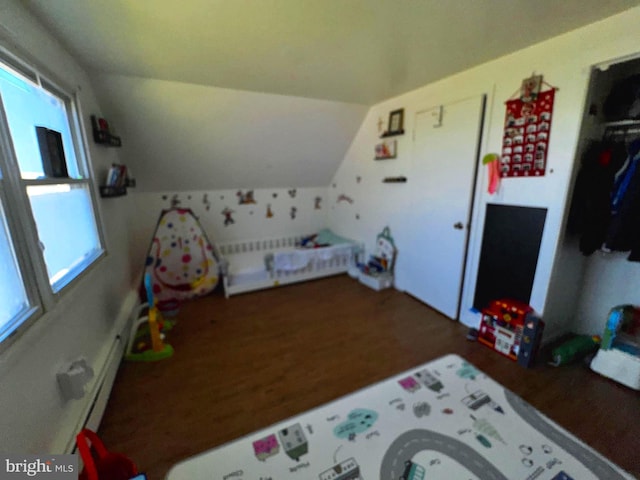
left=27, top=184, right=102, bottom=292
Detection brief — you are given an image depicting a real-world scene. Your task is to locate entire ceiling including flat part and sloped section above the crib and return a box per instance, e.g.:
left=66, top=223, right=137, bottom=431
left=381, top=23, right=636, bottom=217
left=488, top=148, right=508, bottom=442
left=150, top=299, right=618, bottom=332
left=15, top=0, right=640, bottom=193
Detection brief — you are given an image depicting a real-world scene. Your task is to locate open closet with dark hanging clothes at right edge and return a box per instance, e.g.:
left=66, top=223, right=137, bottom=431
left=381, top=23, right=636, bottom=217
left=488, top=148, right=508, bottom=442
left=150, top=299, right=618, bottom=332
left=554, top=51, right=640, bottom=335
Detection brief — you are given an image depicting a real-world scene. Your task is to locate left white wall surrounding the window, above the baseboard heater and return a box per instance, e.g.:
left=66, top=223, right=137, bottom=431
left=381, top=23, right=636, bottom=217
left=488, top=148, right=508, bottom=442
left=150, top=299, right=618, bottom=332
left=0, top=0, right=135, bottom=453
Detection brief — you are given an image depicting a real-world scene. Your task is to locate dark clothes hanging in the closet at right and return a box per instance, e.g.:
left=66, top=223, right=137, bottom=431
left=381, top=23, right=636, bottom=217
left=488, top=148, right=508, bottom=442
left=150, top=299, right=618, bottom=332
left=568, top=127, right=640, bottom=261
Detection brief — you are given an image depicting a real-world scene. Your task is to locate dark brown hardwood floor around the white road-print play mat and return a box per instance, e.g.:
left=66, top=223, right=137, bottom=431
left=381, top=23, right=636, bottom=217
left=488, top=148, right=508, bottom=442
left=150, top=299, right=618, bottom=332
left=100, top=275, right=640, bottom=480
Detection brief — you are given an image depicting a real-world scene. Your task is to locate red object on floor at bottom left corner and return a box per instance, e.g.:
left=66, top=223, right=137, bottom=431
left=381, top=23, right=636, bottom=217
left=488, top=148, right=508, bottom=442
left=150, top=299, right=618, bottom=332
left=76, top=428, right=138, bottom=480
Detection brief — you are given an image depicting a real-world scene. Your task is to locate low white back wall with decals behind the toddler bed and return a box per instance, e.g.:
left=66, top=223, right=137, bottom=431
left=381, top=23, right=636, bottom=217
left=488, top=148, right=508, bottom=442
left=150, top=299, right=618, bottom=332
left=131, top=187, right=333, bottom=269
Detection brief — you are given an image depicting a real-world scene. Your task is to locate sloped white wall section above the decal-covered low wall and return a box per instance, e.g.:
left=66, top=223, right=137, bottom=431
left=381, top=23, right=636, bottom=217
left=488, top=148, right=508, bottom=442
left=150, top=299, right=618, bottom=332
left=94, top=74, right=367, bottom=192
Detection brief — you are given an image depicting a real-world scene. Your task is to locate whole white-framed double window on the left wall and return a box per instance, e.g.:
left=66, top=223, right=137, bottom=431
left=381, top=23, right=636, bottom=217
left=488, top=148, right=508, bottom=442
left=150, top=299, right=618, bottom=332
left=0, top=52, right=103, bottom=342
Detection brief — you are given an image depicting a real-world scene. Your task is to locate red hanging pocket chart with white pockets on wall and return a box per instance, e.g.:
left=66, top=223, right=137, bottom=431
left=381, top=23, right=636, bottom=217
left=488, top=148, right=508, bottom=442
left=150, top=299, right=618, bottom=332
left=500, top=88, right=556, bottom=177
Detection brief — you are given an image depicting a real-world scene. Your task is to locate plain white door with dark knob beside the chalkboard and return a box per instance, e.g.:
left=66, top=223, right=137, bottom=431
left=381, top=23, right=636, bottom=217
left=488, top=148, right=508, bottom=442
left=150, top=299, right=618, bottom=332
left=400, top=96, right=484, bottom=319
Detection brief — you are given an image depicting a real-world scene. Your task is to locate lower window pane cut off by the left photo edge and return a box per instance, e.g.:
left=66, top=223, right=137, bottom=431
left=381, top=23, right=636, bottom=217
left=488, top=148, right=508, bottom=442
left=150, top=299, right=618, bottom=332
left=0, top=201, right=29, bottom=341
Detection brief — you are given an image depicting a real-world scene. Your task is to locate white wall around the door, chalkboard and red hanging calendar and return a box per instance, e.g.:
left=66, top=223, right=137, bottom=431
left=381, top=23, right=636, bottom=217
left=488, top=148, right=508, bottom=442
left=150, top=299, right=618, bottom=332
left=329, top=8, right=640, bottom=335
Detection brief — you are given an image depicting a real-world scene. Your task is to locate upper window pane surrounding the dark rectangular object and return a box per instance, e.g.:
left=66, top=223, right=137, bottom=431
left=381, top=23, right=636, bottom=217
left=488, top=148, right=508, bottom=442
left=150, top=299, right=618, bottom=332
left=0, top=65, right=79, bottom=179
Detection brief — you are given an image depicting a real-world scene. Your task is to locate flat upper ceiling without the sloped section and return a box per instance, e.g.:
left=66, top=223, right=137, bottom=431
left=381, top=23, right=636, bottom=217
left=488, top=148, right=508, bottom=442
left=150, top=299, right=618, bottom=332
left=23, top=0, right=639, bottom=105
